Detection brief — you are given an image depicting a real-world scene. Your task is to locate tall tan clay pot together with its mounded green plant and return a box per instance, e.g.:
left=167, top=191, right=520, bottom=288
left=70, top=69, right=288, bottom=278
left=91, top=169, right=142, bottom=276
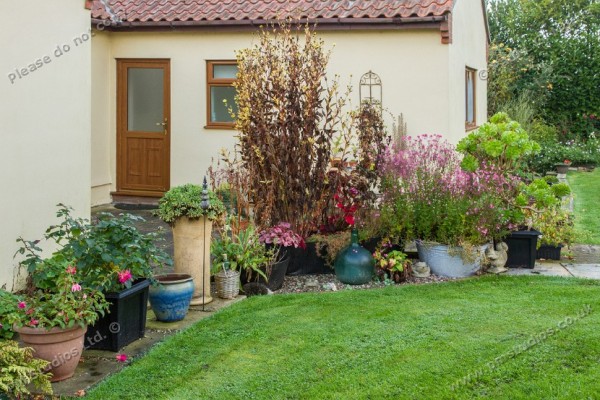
left=155, top=183, right=225, bottom=305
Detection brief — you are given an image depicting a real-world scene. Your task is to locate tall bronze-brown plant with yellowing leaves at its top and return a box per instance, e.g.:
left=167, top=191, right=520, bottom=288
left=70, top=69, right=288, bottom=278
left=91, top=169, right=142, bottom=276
left=234, top=22, right=345, bottom=237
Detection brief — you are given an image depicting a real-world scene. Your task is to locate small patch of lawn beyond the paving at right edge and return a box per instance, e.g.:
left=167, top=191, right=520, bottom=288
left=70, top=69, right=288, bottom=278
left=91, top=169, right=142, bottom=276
left=567, top=168, right=600, bottom=244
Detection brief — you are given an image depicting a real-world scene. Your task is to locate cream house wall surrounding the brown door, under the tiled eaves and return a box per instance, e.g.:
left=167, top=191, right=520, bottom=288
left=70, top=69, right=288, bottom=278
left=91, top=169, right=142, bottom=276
left=92, top=30, right=449, bottom=201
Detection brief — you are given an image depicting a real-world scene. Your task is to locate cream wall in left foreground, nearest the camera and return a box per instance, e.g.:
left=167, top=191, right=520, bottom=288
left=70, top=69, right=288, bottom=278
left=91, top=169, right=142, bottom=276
left=0, top=0, right=91, bottom=290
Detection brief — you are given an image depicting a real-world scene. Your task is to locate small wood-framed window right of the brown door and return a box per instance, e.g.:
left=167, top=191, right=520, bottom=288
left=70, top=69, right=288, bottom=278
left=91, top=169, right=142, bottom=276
left=205, top=60, right=237, bottom=129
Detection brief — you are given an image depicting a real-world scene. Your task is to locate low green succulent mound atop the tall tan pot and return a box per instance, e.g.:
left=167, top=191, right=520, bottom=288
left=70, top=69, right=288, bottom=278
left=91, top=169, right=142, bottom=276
left=154, top=183, right=225, bottom=224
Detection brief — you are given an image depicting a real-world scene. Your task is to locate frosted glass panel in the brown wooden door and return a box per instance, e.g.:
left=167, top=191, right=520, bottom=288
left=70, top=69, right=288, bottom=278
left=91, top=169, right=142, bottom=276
left=127, top=68, right=164, bottom=132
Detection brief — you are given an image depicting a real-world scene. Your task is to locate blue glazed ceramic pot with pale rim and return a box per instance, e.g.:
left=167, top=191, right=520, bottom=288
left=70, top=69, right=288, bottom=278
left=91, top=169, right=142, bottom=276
left=148, top=274, right=194, bottom=322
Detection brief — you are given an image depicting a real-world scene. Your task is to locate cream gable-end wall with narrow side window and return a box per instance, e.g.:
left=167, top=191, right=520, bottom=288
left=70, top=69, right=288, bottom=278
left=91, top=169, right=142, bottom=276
left=448, top=0, right=487, bottom=143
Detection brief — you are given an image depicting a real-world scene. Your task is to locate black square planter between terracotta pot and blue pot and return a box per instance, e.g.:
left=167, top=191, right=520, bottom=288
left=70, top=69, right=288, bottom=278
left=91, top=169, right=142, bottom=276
left=84, top=279, right=150, bottom=351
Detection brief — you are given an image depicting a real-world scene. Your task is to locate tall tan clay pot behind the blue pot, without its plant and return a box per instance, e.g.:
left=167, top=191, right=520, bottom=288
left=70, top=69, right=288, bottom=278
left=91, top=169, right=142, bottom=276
left=173, top=217, right=213, bottom=305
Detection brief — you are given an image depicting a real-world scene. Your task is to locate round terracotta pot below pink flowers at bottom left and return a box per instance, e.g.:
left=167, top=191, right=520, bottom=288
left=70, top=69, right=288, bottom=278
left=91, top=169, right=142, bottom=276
left=14, top=326, right=87, bottom=382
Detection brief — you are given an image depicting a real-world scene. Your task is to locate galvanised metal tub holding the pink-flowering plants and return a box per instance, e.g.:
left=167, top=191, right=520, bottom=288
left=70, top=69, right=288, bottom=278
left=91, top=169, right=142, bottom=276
left=417, top=240, right=487, bottom=278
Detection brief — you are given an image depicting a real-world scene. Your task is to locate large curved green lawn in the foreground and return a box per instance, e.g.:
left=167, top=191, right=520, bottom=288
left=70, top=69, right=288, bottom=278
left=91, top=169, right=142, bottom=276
left=88, top=276, right=600, bottom=399
